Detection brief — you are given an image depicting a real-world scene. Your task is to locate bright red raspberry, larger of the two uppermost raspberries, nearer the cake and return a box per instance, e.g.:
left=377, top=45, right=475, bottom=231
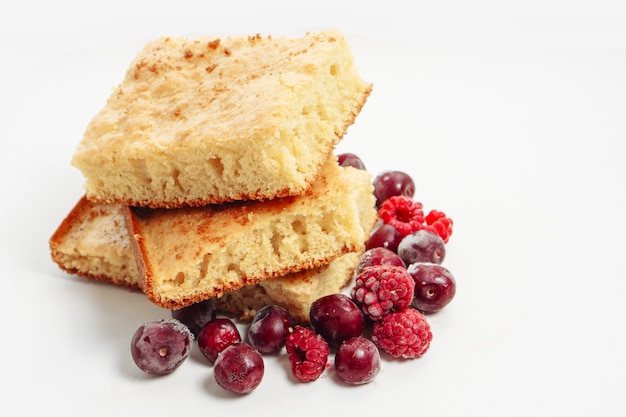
left=378, top=195, right=424, bottom=236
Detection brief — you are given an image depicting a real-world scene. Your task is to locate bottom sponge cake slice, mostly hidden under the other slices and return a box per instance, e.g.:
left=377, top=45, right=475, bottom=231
left=50, top=196, right=369, bottom=323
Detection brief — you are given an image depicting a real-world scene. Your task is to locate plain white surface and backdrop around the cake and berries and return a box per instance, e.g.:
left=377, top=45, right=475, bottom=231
left=0, top=1, right=626, bottom=416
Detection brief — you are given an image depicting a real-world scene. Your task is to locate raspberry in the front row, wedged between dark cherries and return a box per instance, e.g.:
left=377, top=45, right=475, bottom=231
left=285, top=325, right=330, bottom=382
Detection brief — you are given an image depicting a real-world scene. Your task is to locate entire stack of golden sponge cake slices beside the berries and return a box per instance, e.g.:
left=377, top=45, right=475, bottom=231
left=50, top=31, right=376, bottom=321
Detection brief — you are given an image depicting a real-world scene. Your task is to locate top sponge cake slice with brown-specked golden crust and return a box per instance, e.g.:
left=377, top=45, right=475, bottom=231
left=72, top=31, right=371, bottom=208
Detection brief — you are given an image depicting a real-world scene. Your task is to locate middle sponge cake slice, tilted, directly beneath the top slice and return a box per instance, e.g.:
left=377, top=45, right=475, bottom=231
left=125, top=157, right=376, bottom=309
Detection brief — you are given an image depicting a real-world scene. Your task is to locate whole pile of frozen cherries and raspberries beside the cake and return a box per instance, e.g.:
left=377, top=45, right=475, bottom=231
left=131, top=154, right=456, bottom=394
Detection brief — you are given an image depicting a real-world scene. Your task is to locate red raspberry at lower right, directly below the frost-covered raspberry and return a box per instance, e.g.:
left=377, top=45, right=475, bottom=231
left=372, top=308, right=433, bottom=359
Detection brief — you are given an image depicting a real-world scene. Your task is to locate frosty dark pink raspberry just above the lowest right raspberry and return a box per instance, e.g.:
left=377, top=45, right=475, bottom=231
left=351, top=265, right=415, bottom=320
